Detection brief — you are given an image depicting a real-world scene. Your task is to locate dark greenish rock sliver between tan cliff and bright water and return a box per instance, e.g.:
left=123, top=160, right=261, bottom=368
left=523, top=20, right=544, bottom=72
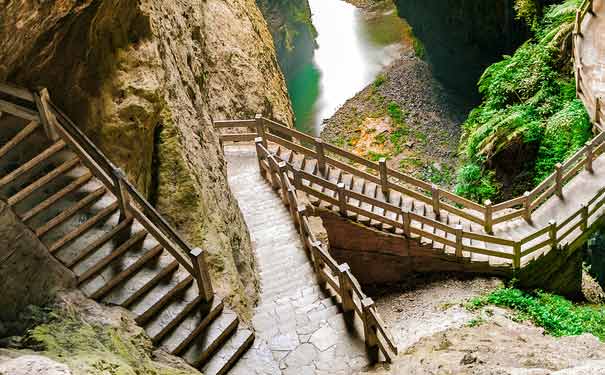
left=256, top=0, right=317, bottom=78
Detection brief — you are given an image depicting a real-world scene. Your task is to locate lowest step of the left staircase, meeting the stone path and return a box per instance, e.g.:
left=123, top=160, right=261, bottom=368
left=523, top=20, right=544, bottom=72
left=202, top=329, right=254, bottom=375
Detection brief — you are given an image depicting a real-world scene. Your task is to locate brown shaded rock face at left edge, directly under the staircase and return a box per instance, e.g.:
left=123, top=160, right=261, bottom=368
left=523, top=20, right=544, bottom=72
left=0, top=200, right=75, bottom=330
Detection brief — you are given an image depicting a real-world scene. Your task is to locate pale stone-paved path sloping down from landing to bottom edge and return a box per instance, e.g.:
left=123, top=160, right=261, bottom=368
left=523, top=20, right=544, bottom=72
left=225, top=146, right=369, bottom=375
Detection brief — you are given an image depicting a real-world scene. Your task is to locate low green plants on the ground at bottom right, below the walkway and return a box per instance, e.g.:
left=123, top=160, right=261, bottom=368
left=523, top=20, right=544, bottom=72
left=467, top=288, right=605, bottom=341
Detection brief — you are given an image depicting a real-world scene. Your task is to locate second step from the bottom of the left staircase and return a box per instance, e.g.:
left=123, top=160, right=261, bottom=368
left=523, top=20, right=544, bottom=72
left=179, top=312, right=239, bottom=368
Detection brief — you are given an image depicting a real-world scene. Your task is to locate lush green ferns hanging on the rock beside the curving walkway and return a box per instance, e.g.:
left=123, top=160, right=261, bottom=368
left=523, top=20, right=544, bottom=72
left=456, top=0, right=591, bottom=200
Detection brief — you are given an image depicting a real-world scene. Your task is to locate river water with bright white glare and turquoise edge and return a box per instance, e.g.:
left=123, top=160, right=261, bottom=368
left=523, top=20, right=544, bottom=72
left=286, top=0, right=410, bottom=135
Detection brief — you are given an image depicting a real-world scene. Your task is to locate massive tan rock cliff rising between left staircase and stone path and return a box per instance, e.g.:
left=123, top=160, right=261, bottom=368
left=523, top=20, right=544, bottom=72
left=0, top=0, right=293, bottom=318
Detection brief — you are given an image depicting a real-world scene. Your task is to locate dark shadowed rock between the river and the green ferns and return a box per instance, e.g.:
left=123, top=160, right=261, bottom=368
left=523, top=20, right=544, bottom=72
left=395, top=0, right=528, bottom=100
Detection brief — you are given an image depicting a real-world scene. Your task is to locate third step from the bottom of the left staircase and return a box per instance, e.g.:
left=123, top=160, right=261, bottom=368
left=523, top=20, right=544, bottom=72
left=162, top=298, right=223, bottom=355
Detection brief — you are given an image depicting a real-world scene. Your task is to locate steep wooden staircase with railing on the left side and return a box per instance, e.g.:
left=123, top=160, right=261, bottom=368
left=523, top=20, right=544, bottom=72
left=0, top=85, right=254, bottom=374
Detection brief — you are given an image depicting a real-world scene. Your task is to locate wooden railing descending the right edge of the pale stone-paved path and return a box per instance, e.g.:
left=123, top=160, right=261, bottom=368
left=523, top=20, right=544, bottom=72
left=256, top=139, right=398, bottom=361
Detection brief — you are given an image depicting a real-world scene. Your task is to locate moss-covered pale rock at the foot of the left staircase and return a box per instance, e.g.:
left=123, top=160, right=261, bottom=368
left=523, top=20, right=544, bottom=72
left=26, top=311, right=197, bottom=375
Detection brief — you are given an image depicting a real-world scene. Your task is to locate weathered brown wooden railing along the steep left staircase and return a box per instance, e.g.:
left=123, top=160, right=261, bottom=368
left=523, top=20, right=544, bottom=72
left=0, top=83, right=214, bottom=301
